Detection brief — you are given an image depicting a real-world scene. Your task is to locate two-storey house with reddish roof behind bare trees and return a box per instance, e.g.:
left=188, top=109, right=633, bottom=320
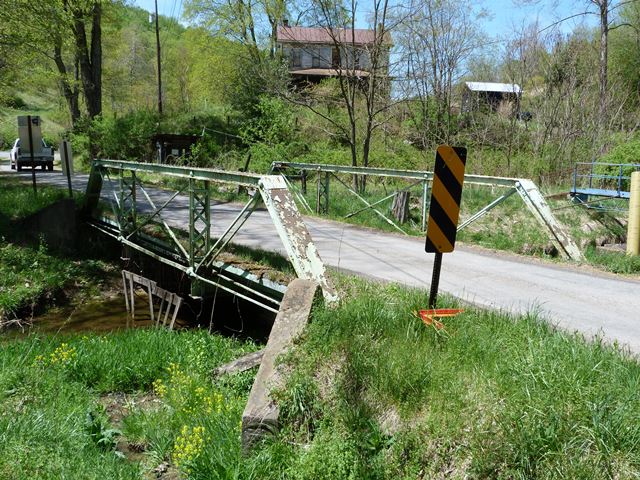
left=276, top=22, right=391, bottom=83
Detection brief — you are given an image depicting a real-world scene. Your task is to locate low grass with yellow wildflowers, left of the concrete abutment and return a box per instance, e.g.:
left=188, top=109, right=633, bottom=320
left=0, top=329, right=256, bottom=479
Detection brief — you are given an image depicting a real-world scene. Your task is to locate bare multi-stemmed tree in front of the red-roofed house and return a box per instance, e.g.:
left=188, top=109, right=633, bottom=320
left=281, top=0, right=395, bottom=193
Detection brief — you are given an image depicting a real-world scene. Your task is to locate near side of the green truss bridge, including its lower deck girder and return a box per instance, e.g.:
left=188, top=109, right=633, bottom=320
left=86, top=160, right=337, bottom=312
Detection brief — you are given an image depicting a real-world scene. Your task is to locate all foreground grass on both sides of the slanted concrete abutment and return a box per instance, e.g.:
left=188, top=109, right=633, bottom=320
left=0, top=277, right=640, bottom=480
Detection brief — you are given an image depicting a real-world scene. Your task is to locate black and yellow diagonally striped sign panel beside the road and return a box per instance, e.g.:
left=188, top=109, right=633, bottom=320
left=425, top=145, right=467, bottom=253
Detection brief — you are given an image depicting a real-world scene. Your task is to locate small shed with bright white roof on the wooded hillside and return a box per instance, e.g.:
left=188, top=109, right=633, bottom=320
left=462, top=82, right=522, bottom=114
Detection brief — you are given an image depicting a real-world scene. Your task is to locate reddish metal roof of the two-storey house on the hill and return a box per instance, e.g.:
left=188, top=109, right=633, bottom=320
left=276, top=25, right=391, bottom=45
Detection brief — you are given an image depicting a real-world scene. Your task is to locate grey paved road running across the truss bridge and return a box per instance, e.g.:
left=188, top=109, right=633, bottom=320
left=5, top=165, right=640, bottom=353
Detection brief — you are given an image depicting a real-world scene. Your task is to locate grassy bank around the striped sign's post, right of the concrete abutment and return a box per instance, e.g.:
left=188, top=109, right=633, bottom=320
left=258, top=279, right=640, bottom=479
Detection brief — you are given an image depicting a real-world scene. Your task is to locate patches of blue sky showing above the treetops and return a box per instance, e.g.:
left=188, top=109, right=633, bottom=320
left=134, top=0, right=597, bottom=38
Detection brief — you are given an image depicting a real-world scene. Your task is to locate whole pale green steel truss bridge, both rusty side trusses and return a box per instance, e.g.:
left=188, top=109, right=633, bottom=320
left=86, top=160, right=582, bottom=312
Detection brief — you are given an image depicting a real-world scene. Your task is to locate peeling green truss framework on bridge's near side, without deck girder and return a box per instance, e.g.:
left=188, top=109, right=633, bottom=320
left=86, top=160, right=337, bottom=310
